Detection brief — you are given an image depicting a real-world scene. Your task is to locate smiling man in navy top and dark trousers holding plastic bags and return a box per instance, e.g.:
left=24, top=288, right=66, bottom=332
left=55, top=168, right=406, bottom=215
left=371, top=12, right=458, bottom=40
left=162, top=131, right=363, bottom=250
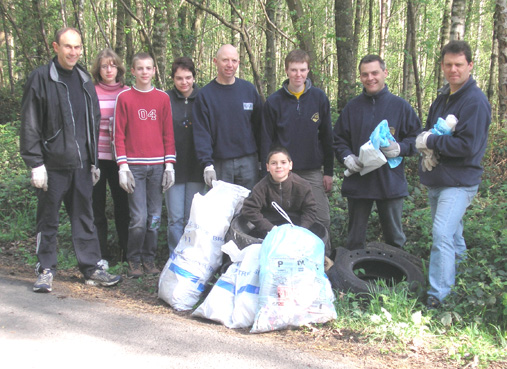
left=334, top=55, right=421, bottom=250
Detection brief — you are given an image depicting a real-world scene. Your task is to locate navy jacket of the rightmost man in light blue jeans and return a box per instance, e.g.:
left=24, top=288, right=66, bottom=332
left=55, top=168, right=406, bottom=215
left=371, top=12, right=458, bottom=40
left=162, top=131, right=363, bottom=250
left=419, top=77, right=491, bottom=187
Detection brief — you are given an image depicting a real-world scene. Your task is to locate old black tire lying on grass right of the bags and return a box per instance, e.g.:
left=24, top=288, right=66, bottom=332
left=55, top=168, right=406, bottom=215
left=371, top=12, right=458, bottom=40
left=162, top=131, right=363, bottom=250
left=327, top=248, right=424, bottom=294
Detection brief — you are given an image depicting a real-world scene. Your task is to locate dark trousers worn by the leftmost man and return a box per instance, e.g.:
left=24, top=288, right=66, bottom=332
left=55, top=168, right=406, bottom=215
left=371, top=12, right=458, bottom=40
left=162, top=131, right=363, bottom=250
left=37, top=164, right=100, bottom=278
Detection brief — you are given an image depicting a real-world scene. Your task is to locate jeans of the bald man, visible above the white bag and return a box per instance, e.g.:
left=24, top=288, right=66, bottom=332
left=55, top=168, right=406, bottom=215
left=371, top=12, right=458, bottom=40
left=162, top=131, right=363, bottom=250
left=214, top=154, right=259, bottom=190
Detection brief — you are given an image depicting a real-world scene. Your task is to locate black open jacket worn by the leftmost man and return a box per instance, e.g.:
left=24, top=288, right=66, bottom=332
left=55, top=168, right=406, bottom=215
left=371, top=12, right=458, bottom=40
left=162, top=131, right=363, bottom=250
left=20, top=59, right=100, bottom=170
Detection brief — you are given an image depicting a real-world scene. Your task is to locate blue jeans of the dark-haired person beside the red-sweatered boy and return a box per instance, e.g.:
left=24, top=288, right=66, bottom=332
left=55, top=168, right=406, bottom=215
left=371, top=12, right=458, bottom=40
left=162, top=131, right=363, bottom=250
left=165, top=182, right=204, bottom=255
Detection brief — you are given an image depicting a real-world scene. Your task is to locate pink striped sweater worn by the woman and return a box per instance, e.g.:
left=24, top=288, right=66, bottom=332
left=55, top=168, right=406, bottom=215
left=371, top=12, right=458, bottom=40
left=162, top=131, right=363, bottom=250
left=95, top=82, right=128, bottom=160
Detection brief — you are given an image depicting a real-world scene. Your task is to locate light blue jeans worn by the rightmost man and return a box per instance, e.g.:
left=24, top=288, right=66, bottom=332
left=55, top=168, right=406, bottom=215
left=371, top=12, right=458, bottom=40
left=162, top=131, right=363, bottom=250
left=428, top=185, right=479, bottom=301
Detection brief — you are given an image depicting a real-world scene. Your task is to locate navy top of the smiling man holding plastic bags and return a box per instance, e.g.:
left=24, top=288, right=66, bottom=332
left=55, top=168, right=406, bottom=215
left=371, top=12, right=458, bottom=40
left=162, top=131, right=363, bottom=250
left=334, top=85, right=421, bottom=200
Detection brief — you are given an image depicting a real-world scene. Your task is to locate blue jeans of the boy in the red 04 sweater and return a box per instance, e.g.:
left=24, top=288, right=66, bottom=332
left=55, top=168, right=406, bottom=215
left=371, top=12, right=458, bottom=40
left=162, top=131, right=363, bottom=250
left=127, top=164, right=164, bottom=262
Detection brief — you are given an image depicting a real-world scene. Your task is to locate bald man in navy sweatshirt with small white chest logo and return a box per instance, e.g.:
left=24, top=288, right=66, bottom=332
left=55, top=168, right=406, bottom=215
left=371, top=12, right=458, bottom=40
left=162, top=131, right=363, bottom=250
left=193, top=45, right=262, bottom=190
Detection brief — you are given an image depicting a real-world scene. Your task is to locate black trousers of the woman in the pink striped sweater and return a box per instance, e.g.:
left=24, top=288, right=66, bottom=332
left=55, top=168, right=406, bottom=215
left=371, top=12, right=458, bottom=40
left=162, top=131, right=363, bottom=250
left=93, top=160, right=130, bottom=261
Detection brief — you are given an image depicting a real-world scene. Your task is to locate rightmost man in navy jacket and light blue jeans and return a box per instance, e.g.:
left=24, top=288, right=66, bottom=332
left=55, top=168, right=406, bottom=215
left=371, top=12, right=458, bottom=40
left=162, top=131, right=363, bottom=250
left=416, top=41, right=491, bottom=308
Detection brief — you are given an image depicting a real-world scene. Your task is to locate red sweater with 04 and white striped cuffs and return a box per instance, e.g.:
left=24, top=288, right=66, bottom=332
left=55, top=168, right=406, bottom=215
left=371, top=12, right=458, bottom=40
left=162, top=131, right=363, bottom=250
left=114, top=87, right=176, bottom=165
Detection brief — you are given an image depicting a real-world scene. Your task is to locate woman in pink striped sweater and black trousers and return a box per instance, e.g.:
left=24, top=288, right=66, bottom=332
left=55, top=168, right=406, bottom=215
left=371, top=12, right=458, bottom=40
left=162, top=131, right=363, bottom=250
left=91, top=48, right=130, bottom=265
